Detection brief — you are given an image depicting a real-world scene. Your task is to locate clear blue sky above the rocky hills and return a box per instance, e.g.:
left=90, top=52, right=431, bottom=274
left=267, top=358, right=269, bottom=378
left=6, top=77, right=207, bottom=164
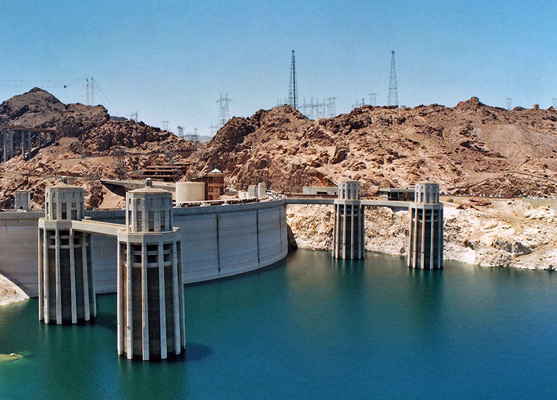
left=0, top=0, right=557, bottom=134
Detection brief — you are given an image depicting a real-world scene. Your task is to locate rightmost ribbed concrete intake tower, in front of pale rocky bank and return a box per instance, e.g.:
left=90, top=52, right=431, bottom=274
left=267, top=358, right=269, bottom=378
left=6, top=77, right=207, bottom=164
left=408, top=182, right=443, bottom=269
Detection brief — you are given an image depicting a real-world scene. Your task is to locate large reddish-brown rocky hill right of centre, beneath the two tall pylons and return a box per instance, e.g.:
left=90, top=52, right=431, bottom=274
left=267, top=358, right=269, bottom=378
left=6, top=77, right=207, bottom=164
left=188, top=98, right=557, bottom=196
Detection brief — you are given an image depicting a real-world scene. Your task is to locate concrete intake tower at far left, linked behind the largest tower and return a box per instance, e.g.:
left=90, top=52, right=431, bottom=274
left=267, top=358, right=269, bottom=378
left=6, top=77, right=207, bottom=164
left=38, top=181, right=97, bottom=324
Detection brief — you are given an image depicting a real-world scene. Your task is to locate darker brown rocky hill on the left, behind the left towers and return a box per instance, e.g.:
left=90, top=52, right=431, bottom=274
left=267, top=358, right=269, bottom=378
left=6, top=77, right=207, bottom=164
left=0, top=88, right=194, bottom=208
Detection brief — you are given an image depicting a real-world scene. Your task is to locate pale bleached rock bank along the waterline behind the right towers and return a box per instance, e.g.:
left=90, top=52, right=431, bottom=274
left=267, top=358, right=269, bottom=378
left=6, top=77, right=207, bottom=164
left=286, top=198, right=557, bottom=269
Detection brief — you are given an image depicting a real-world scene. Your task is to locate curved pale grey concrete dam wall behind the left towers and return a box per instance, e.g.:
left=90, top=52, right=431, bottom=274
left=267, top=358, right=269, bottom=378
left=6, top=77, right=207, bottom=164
left=0, top=200, right=288, bottom=297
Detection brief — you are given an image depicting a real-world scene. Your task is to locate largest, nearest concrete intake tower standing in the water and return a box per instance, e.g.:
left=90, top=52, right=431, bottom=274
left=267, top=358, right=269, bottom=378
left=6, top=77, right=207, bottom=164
left=117, top=182, right=186, bottom=360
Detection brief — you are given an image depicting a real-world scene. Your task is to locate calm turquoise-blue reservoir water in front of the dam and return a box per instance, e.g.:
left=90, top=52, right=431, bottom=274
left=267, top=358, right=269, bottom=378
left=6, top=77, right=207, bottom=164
left=0, top=250, right=557, bottom=400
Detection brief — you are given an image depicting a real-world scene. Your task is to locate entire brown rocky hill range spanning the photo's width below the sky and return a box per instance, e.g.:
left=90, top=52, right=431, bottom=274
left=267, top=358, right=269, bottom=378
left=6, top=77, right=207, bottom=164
left=0, top=88, right=557, bottom=208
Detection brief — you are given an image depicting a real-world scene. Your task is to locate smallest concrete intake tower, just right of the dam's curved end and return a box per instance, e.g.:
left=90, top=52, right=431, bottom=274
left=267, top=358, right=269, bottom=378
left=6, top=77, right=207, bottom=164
left=333, top=181, right=365, bottom=259
